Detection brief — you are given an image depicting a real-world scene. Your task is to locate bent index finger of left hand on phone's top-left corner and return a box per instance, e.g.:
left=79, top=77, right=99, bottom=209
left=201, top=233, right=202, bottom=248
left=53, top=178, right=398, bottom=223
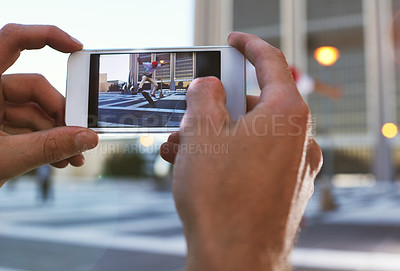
left=0, top=24, right=83, bottom=74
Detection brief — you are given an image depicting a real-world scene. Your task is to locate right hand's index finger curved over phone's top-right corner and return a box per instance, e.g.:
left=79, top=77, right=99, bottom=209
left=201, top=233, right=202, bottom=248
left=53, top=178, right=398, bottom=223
left=228, top=32, right=297, bottom=100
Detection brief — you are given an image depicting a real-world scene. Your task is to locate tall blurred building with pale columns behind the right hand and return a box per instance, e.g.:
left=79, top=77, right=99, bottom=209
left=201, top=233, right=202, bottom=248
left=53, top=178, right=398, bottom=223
left=195, top=0, right=400, bottom=183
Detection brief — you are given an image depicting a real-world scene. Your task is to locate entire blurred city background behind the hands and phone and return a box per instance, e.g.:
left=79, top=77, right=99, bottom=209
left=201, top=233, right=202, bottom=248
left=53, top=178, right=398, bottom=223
left=0, top=0, right=400, bottom=271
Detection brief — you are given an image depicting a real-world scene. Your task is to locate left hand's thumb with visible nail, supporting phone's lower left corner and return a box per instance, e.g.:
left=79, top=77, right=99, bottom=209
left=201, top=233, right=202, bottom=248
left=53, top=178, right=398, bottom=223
left=0, top=127, right=98, bottom=181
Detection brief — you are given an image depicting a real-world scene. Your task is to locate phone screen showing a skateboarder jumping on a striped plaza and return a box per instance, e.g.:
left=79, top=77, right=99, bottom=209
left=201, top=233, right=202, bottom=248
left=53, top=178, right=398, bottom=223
left=88, top=51, right=221, bottom=128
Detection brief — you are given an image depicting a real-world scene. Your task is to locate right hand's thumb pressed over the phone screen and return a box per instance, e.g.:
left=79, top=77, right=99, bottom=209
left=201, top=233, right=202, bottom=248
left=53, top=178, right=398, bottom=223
left=181, top=77, right=230, bottom=135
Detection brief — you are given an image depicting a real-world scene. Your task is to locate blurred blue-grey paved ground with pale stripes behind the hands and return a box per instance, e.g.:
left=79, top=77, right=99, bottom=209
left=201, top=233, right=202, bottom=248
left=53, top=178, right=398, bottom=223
left=0, top=177, right=400, bottom=271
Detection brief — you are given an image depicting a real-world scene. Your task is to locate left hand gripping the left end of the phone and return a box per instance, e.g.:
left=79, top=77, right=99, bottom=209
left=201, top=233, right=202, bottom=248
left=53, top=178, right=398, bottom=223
left=0, top=24, right=98, bottom=187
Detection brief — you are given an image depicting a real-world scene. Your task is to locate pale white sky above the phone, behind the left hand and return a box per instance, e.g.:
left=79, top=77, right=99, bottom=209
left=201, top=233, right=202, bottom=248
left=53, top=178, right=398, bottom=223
left=0, top=0, right=194, bottom=94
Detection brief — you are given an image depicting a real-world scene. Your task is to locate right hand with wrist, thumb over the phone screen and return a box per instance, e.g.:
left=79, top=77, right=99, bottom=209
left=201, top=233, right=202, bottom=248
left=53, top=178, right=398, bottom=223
left=160, top=33, right=322, bottom=271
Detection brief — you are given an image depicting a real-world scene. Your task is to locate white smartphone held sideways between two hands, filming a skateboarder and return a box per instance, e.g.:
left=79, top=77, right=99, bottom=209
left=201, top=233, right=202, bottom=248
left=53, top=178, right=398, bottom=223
left=66, top=46, right=246, bottom=133
